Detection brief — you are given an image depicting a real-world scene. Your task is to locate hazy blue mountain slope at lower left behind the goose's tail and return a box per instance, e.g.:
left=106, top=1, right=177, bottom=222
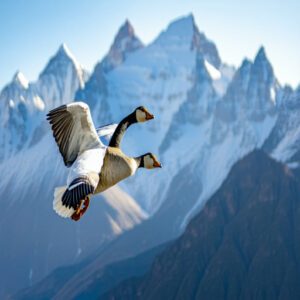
left=0, top=134, right=147, bottom=295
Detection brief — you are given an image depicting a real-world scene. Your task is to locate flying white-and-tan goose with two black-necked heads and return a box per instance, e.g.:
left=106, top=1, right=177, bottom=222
left=47, top=102, right=161, bottom=221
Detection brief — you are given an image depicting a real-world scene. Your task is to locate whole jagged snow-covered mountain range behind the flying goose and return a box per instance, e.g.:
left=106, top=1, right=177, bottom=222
left=0, top=15, right=300, bottom=298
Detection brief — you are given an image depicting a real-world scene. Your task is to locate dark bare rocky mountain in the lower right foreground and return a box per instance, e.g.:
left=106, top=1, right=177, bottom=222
left=103, top=151, right=300, bottom=299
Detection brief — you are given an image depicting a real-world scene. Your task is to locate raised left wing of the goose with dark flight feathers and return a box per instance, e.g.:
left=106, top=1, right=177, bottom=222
left=47, top=102, right=102, bottom=167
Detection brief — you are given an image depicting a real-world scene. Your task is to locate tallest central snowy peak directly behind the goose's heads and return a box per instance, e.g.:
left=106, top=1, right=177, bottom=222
left=76, top=15, right=232, bottom=212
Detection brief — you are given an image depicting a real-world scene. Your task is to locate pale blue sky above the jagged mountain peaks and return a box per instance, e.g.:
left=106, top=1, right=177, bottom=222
left=0, top=0, right=300, bottom=89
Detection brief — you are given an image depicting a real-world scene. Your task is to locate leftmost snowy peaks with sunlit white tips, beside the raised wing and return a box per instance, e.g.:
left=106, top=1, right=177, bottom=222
left=0, top=44, right=87, bottom=161
